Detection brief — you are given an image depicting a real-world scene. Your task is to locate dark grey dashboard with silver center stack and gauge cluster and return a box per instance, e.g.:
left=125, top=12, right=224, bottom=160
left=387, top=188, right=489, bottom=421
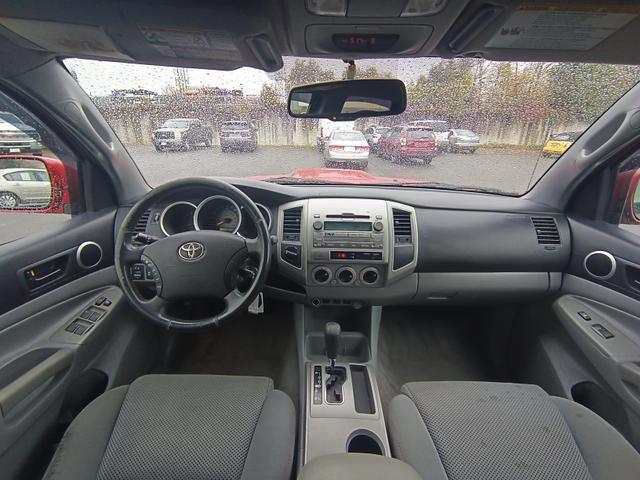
left=125, top=179, right=570, bottom=307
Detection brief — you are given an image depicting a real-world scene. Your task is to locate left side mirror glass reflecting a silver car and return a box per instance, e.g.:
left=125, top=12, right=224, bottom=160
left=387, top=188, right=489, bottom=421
left=0, top=168, right=51, bottom=209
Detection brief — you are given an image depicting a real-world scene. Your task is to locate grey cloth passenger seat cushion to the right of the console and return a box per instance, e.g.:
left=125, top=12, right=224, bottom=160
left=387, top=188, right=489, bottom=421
left=387, top=382, right=640, bottom=480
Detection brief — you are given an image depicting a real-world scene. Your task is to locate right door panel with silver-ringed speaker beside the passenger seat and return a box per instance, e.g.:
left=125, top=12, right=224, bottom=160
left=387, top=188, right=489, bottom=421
left=553, top=219, right=640, bottom=449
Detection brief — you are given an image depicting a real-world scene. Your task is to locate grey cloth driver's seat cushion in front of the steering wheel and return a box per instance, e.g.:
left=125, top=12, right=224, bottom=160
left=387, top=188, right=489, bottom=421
left=45, top=375, right=295, bottom=480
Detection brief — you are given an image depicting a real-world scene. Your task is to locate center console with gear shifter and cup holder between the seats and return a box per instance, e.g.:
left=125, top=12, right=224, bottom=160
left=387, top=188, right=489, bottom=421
left=296, top=305, right=390, bottom=466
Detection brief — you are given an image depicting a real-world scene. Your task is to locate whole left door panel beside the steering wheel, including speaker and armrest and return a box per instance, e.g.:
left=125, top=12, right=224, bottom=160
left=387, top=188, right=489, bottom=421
left=0, top=209, right=155, bottom=479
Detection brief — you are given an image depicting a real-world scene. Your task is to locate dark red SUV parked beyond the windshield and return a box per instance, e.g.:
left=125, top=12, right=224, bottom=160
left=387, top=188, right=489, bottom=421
left=378, top=125, right=438, bottom=164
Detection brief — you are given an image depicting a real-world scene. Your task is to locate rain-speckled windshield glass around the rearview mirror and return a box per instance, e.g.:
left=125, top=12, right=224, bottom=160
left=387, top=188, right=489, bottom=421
left=65, top=58, right=640, bottom=195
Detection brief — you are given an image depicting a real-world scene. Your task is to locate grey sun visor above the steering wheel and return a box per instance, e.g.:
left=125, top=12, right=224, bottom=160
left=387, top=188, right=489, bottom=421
left=0, top=2, right=282, bottom=71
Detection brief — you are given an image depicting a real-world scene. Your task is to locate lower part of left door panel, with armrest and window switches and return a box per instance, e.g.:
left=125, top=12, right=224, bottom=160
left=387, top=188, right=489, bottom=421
left=0, top=267, right=155, bottom=478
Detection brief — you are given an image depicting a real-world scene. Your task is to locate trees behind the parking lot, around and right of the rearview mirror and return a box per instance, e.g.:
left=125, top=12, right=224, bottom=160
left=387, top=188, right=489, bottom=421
left=268, top=58, right=640, bottom=135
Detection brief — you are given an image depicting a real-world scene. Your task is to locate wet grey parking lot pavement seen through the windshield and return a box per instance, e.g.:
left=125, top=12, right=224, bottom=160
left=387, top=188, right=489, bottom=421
left=128, top=146, right=553, bottom=192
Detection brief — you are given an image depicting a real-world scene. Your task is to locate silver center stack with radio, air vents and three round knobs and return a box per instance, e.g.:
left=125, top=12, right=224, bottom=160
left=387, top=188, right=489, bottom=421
left=278, top=198, right=418, bottom=303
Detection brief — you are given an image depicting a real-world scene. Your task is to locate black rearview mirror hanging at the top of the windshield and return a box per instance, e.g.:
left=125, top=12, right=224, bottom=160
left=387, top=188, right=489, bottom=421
left=289, top=80, right=407, bottom=121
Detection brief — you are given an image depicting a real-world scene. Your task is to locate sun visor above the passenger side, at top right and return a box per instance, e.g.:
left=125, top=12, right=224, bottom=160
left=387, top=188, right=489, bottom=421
left=437, top=1, right=640, bottom=64
